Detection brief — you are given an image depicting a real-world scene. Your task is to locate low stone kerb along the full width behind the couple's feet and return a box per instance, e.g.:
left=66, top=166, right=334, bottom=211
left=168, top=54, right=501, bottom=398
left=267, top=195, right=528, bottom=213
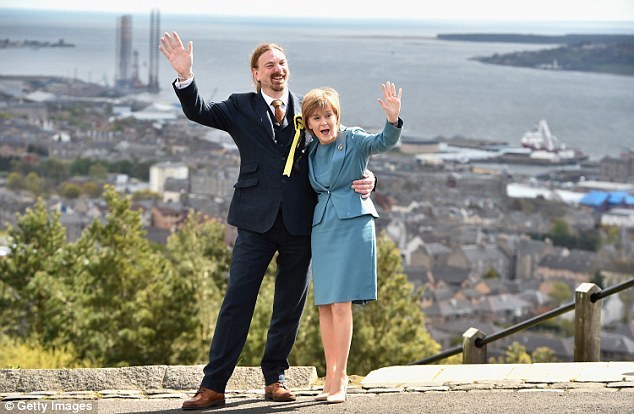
left=0, top=362, right=634, bottom=398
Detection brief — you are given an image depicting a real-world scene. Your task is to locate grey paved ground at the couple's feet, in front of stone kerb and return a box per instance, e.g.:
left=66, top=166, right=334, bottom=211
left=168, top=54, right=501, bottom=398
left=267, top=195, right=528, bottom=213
left=90, top=389, right=634, bottom=414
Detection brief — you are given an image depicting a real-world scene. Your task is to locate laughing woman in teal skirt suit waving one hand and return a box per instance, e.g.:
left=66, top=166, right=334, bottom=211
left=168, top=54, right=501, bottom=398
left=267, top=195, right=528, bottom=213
left=302, top=82, right=403, bottom=403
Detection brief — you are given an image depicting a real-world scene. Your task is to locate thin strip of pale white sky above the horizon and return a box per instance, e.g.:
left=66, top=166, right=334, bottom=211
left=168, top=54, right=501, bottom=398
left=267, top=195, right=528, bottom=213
left=0, top=0, right=634, bottom=21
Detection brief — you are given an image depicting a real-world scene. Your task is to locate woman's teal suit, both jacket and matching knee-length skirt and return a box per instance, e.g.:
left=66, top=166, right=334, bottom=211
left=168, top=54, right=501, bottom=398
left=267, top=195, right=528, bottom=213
left=308, top=119, right=403, bottom=305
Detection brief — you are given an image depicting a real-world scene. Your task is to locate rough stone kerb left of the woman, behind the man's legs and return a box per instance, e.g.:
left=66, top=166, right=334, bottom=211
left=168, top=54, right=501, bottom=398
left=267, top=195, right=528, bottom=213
left=0, top=365, right=317, bottom=393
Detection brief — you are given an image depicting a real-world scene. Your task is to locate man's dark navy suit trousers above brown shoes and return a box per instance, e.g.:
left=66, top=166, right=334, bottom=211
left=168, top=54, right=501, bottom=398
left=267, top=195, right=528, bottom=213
left=201, top=211, right=311, bottom=393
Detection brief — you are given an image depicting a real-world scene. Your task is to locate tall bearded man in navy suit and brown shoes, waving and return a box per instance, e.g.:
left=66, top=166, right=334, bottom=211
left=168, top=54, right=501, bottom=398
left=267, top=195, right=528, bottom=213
left=160, top=32, right=374, bottom=410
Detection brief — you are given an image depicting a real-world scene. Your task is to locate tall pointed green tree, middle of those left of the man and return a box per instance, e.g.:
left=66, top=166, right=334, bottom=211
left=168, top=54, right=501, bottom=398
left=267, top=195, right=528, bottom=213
left=66, top=186, right=171, bottom=366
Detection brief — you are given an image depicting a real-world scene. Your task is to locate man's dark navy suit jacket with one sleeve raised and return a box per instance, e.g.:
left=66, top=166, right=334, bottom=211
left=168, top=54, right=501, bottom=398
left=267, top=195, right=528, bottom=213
left=174, top=82, right=317, bottom=236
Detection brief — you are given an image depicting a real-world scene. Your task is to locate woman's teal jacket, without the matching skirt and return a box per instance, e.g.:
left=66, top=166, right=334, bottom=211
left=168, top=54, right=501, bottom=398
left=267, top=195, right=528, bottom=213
left=307, top=118, right=403, bottom=226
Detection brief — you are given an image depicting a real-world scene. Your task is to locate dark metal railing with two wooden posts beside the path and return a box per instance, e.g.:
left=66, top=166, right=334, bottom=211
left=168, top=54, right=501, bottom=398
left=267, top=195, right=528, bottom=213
left=408, top=278, right=634, bottom=365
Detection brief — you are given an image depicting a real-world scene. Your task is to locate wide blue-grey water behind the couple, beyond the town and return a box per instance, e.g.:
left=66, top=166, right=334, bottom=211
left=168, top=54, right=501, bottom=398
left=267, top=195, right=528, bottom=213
left=0, top=9, right=634, bottom=159
